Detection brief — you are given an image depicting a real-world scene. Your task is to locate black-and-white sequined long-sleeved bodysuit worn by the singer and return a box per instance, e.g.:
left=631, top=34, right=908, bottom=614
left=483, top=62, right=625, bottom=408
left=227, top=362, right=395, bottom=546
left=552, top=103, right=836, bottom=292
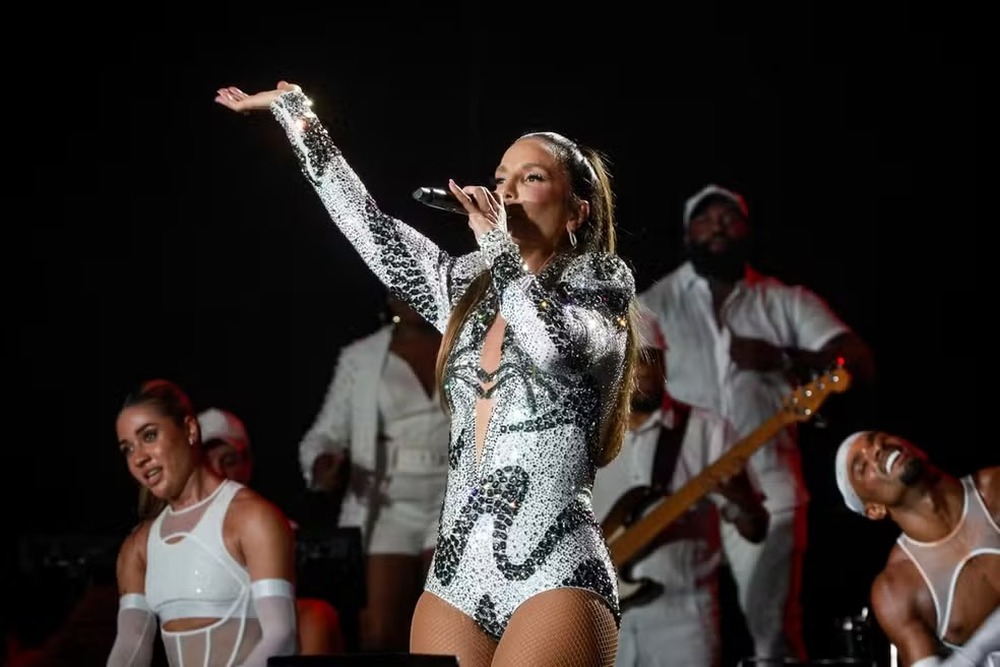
left=271, top=92, right=635, bottom=639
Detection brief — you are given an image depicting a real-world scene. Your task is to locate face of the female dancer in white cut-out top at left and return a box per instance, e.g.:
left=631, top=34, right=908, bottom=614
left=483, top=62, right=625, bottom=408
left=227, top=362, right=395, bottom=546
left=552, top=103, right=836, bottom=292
left=115, top=403, right=198, bottom=499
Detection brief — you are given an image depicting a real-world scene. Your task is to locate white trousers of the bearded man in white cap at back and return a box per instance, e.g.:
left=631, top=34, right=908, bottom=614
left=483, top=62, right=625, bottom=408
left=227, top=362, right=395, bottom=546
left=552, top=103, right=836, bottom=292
left=722, top=504, right=808, bottom=660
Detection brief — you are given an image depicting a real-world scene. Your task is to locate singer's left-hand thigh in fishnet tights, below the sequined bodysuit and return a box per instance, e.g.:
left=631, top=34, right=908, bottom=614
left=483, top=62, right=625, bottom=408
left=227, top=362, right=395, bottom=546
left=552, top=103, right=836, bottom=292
left=410, top=591, right=496, bottom=667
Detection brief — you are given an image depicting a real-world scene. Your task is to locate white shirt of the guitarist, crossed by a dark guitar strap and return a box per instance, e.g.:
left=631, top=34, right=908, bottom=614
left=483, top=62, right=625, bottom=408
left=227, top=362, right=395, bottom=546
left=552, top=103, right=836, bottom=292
left=592, top=407, right=737, bottom=600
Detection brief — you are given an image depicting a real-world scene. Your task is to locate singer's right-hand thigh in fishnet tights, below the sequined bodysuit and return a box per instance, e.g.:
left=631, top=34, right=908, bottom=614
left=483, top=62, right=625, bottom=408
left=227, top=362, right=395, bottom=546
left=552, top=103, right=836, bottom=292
left=492, top=588, right=618, bottom=667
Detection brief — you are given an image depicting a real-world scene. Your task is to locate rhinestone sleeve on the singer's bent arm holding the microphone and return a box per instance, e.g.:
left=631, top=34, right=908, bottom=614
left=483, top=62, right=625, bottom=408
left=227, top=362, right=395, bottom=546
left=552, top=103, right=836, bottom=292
left=479, top=229, right=635, bottom=372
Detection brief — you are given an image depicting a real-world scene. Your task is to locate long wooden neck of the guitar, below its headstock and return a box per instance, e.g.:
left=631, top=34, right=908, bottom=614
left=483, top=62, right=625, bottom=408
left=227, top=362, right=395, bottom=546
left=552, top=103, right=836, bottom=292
left=608, top=412, right=788, bottom=567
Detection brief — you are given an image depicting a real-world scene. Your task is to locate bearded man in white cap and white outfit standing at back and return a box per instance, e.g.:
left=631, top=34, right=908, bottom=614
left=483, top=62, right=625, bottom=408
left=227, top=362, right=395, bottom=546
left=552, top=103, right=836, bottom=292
left=639, top=185, right=874, bottom=660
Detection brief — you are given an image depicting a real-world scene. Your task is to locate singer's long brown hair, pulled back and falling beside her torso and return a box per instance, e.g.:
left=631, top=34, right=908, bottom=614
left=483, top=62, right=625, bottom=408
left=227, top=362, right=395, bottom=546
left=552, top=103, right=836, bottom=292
left=437, top=132, right=638, bottom=466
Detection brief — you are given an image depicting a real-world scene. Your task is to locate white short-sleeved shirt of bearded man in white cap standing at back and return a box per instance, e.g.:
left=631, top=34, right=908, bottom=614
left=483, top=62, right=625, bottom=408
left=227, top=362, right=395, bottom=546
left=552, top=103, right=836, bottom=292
left=639, top=262, right=848, bottom=511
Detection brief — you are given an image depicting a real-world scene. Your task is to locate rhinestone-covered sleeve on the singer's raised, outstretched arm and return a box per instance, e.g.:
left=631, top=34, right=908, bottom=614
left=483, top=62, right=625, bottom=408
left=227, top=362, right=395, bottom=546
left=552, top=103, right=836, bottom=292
left=271, top=91, right=486, bottom=331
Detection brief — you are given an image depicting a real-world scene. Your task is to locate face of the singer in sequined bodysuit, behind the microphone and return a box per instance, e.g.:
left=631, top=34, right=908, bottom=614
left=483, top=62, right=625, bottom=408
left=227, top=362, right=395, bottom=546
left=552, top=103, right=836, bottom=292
left=495, top=138, right=579, bottom=252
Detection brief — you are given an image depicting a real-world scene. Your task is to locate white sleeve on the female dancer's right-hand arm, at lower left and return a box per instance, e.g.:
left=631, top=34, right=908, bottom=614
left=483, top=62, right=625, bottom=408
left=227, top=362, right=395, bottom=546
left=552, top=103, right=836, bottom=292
left=241, top=579, right=298, bottom=667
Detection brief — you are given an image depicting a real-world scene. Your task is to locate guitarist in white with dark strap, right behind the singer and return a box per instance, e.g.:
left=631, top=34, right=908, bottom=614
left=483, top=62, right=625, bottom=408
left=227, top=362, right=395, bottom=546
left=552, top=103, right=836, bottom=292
left=593, top=317, right=768, bottom=667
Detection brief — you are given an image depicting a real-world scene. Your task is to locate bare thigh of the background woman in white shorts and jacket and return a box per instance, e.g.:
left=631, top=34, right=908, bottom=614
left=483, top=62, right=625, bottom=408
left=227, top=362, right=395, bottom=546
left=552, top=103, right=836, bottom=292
left=361, top=554, right=424, bottom=651
